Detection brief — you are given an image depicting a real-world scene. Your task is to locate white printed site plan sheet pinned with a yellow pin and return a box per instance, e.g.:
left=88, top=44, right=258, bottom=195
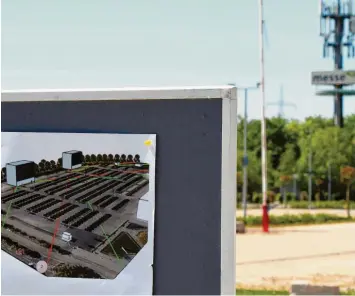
left=1, top=132, right=156, bottom=295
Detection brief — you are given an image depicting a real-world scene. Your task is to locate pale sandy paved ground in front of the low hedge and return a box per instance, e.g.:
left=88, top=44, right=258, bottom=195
left=236, top=223, right=355, bottom=289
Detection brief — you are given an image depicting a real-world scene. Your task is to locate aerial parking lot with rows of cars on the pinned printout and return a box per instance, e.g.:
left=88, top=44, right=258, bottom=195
left=1, top=163, right=149, bottom=279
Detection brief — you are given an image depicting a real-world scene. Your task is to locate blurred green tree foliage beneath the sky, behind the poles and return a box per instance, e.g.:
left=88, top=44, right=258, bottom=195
left=237, top=114, right=355, bottom=198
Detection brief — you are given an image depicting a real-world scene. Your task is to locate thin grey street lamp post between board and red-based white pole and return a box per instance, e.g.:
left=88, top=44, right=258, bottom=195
left=241, top=83, right=260, bottom=218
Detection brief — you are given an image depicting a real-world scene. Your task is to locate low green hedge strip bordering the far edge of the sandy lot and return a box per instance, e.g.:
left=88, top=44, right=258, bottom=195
left=237, top=214, right=355, bottom=226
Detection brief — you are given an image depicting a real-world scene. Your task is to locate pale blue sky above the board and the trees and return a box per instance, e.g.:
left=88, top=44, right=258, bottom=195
left=2, top=0, right=355, bottom=118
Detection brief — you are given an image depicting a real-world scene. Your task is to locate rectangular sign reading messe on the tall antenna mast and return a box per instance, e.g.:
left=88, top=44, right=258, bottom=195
left=312, top=70, right=355, bottom=85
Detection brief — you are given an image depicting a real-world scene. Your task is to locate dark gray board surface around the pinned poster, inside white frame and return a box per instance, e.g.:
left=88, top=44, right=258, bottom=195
left=1, top=99, right=222, bottom=295
